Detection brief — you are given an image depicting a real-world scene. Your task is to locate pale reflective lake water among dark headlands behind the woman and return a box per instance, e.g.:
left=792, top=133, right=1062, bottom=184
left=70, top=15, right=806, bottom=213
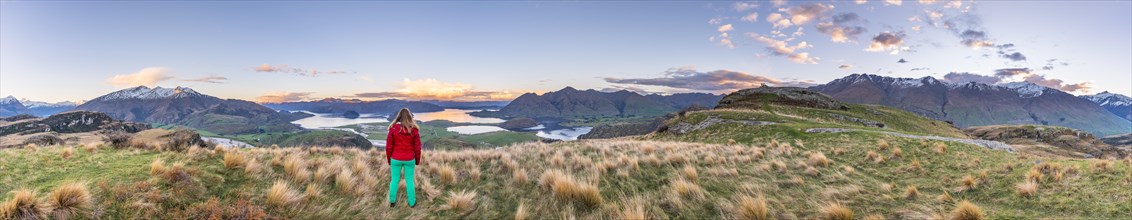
left=293, top=109, right=592, bottom=142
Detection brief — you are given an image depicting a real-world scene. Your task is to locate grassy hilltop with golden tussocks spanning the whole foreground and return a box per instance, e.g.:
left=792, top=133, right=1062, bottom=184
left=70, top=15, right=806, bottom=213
left=0, top=100, right=1132, bottom=219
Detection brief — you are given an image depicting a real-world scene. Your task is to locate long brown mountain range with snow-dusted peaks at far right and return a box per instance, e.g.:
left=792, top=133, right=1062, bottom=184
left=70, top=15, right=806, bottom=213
left=811, top=74, right=1132, bottom=136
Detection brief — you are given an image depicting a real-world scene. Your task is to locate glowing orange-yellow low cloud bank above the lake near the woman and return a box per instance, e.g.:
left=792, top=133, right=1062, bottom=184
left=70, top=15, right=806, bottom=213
left=353, top=78, right=515, bottom=101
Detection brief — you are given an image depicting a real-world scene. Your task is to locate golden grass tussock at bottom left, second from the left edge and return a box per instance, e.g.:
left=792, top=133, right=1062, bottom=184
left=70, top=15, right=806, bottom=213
left=48, top=183, right=93, bottom=219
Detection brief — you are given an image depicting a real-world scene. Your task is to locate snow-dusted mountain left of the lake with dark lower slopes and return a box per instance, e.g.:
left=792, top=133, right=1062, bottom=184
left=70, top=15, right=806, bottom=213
left=75, top=86, right=300, bottom=135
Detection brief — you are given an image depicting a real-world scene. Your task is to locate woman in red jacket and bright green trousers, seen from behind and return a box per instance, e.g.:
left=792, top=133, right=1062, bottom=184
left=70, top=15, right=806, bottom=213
left=385, top=109, right=421, bottom=208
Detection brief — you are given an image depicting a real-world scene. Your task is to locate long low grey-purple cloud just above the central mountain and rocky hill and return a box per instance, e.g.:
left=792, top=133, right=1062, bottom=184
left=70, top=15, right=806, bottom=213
left=604, top=67, right=813, bottom=91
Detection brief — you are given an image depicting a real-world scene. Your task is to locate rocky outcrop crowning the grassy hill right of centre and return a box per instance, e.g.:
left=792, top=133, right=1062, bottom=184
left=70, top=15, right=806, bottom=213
left=715, top=86, right=849, bottom=110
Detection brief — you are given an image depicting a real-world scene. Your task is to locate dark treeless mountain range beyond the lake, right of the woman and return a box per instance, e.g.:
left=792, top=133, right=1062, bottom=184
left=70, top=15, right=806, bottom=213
left=472, top=87, right=721, bottom=118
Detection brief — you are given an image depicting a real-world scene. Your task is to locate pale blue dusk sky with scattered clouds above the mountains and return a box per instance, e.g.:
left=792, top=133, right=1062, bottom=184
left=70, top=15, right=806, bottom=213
left=0, top=0, right=1132, bottom=102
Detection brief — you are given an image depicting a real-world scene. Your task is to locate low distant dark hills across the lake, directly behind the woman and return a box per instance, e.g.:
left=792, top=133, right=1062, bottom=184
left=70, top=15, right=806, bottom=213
left=264, top=98, right=444, bottom=115
